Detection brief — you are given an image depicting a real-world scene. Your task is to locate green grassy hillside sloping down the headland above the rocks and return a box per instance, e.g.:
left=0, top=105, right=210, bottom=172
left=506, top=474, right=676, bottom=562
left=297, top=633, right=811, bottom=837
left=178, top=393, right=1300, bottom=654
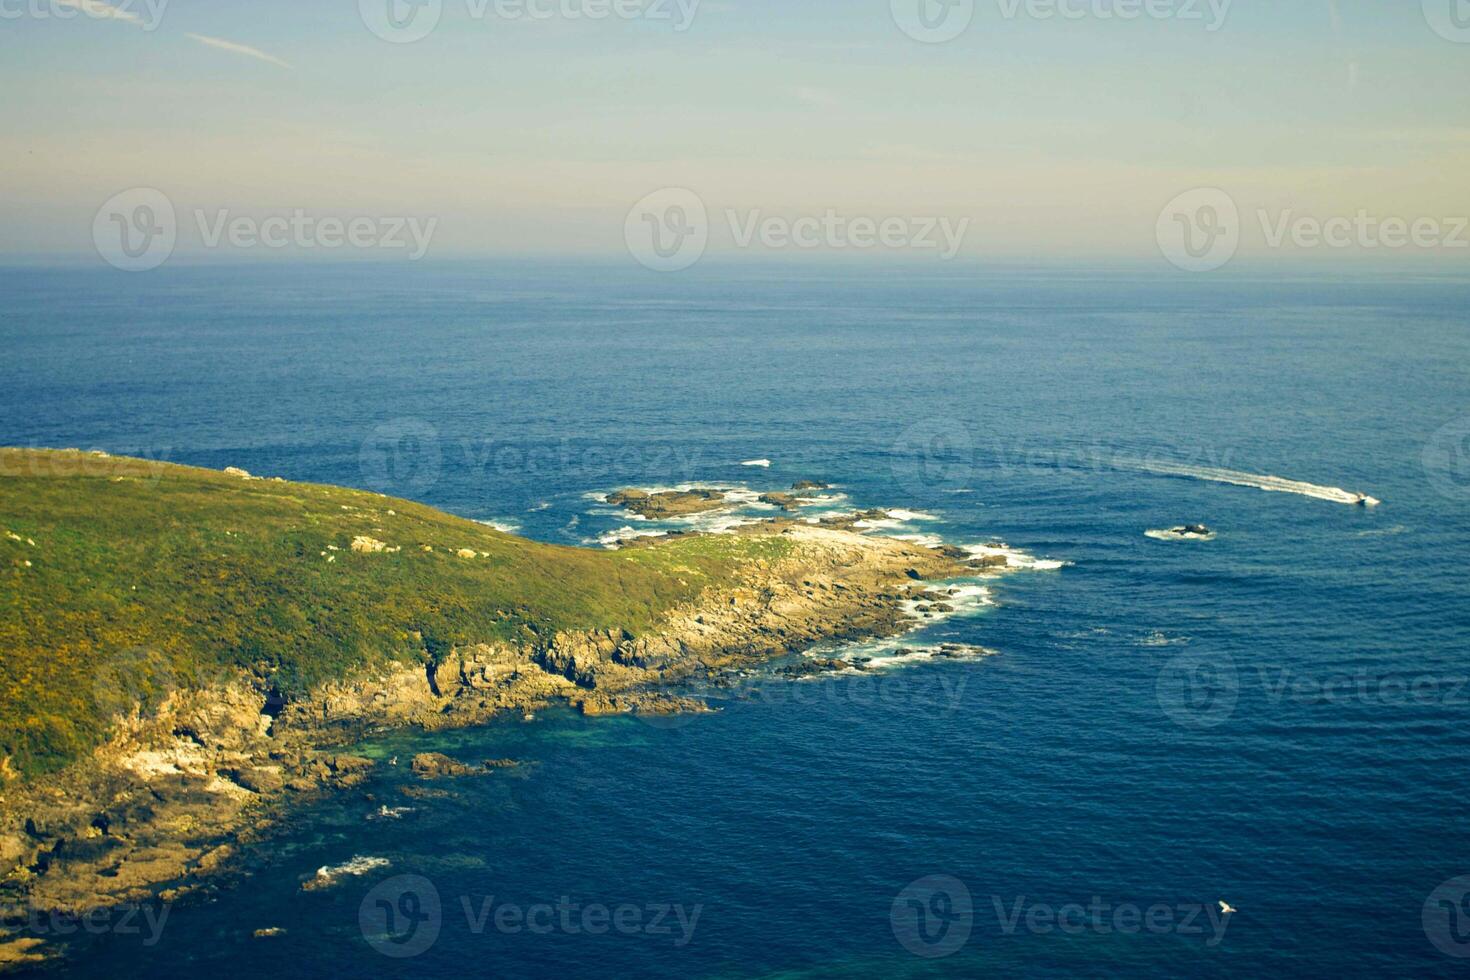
left=0, top=450, right=782, bottom=774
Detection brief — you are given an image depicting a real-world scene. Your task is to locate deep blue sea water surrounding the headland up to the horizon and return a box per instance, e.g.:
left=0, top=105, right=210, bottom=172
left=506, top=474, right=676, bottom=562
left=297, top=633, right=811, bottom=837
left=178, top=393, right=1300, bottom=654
left=0, top=263, right=1470, bottom=977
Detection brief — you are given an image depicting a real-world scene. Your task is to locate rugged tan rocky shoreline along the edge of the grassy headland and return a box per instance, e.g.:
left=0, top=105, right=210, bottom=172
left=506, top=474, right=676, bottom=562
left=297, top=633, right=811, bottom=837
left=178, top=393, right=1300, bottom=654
left=0, top=522, right=975, bottom=968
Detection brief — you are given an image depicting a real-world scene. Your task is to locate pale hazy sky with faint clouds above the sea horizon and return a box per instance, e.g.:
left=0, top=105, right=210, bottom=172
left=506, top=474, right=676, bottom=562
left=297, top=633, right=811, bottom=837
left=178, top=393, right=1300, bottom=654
left=0, top=0, right=1470, bottom=259
